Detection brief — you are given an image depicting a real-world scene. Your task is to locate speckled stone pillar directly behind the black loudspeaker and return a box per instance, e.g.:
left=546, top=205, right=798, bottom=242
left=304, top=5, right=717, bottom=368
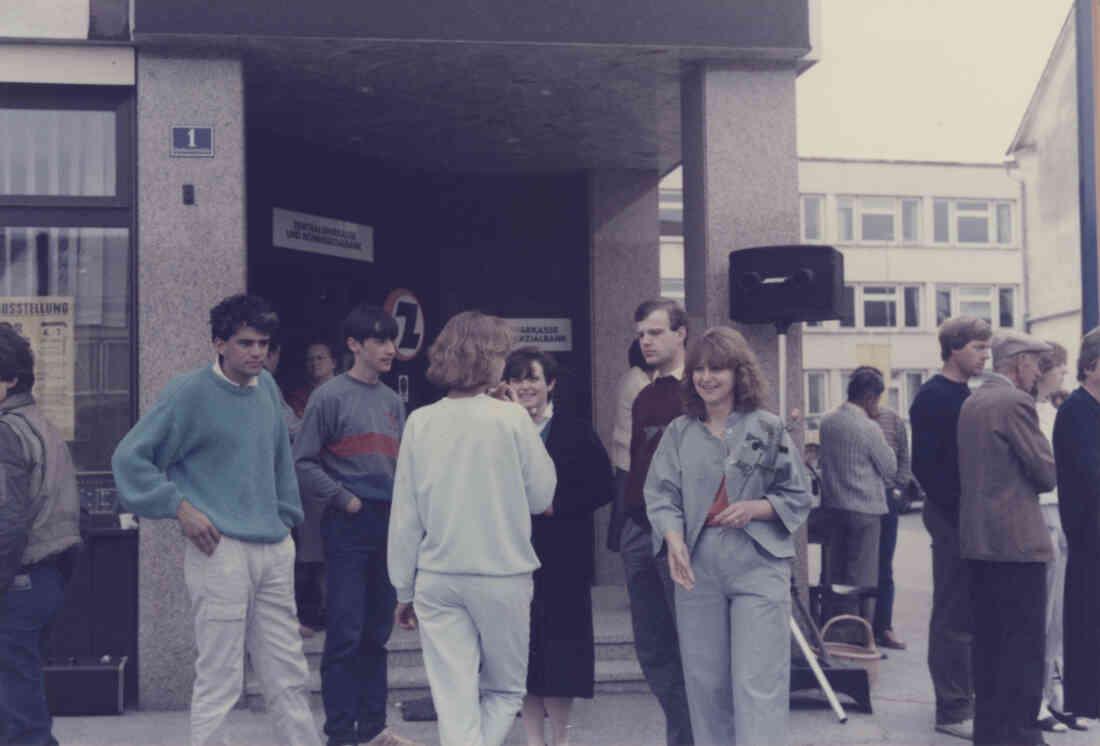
left=681, top=64, right=806, bottom=588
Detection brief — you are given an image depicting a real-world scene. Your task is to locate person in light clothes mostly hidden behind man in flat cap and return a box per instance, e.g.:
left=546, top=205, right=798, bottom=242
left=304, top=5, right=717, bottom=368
left=1035, top=341, right=1067, bottom=733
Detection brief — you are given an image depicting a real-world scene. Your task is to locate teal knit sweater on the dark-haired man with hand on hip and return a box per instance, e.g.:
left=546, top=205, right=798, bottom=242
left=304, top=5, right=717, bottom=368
left=111, top=365, right=303, bottom=542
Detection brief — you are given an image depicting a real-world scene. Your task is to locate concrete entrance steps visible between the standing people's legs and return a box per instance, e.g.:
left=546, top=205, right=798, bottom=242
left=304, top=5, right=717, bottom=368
left=242, top=586, right=649, bottom=711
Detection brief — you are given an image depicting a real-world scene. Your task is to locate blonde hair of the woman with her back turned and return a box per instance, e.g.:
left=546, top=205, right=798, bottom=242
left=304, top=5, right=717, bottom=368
left=428, top=311, right=512, bottom=391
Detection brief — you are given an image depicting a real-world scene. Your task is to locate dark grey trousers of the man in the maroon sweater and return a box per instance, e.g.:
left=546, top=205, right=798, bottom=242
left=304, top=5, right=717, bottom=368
left=619, top=518, right=693, bottom=746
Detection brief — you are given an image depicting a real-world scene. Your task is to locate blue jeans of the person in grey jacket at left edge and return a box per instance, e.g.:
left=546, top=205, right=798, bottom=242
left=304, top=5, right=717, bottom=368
left=0, top=563, right=65, bottom=746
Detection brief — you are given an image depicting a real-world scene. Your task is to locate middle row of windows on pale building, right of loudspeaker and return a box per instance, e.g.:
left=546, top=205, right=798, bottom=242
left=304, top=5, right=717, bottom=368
left=806, top=284, right=1018, bottom=329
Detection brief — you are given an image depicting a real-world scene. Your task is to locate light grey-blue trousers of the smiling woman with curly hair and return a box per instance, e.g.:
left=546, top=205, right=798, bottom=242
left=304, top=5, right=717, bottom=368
left=675, top=528, right=791, bottom=745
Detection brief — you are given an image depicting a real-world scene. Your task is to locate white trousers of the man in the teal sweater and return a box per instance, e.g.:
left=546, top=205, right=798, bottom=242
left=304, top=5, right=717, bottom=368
left=184, top=536, right=321, bottom=746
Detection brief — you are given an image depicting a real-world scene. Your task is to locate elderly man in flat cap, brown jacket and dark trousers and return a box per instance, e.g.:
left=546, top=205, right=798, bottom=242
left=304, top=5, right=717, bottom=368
left=958, top=331, right=1055, bottom=745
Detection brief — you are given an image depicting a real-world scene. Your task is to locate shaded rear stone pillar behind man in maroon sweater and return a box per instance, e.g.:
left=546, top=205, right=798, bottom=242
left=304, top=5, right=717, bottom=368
left=589, top=171, right=660, bottom=585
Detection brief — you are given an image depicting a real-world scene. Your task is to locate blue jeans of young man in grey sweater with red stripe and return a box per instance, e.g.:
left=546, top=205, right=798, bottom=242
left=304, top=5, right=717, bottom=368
left=321, top=501, right=397, bottom=743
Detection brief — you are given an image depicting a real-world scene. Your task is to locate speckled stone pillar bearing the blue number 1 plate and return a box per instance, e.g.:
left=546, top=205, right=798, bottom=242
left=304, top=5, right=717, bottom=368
left=138, top=53, right=245, bottom=710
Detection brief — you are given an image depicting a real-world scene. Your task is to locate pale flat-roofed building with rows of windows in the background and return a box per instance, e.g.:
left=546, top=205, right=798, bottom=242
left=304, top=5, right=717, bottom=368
left=660, top=158, right=1025, bottom=428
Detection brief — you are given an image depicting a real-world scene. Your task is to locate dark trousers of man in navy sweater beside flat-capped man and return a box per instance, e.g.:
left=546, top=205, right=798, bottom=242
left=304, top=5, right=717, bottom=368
left=924, top=500, right=974, bottom=724
